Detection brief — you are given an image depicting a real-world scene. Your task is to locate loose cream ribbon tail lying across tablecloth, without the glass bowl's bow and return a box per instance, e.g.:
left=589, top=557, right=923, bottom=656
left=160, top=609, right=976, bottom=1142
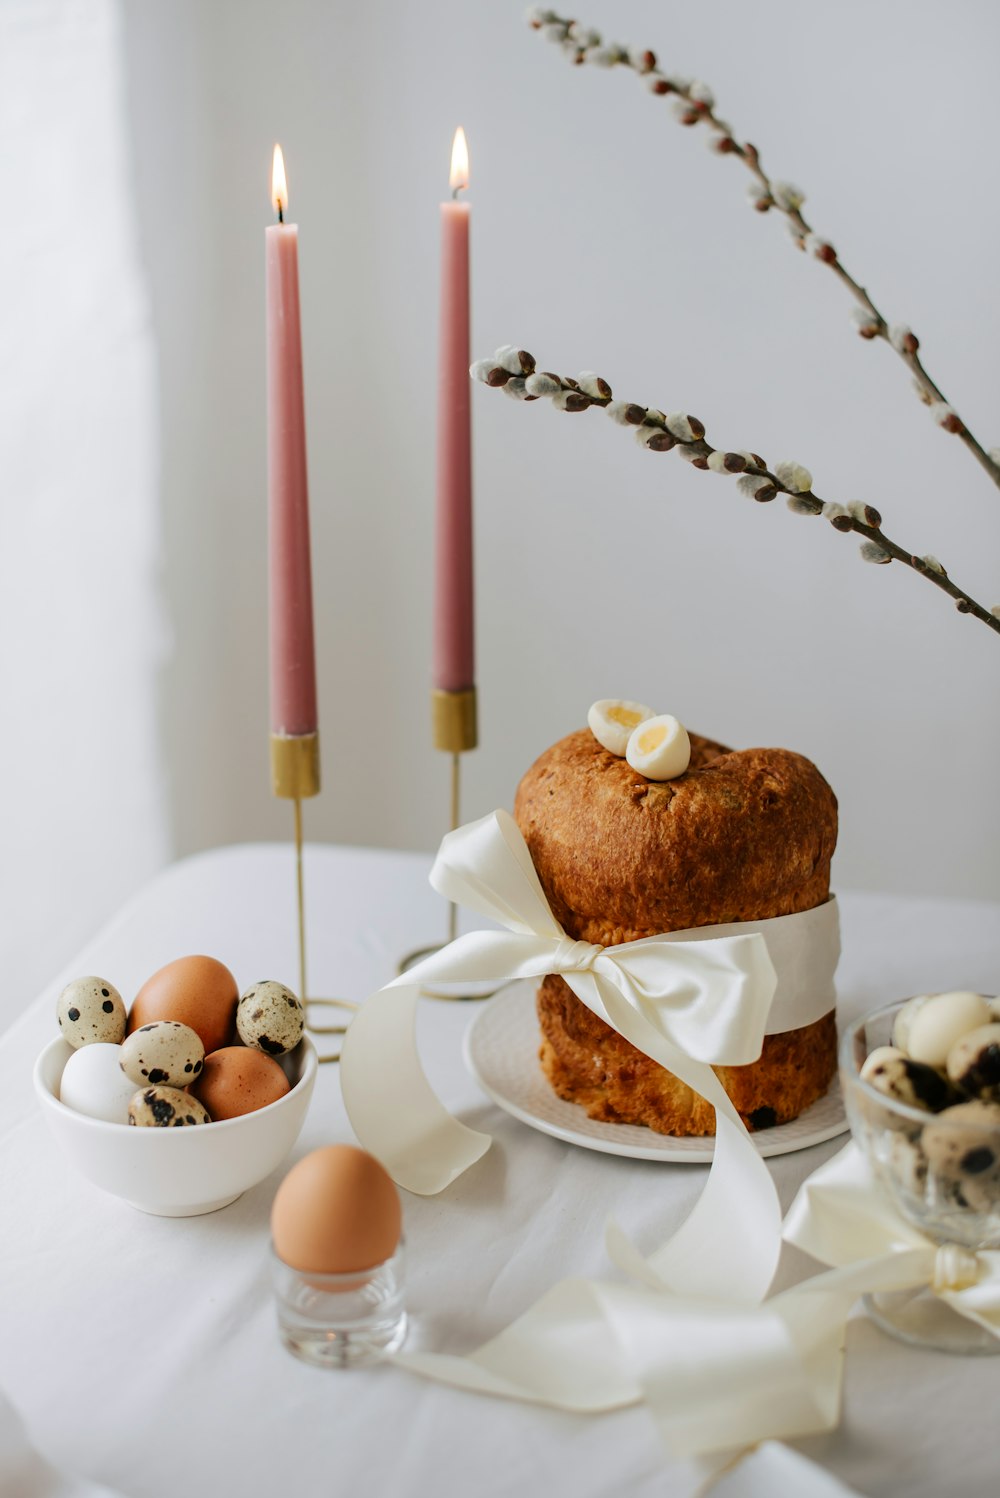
left=394, top=1222, right=912, bottom=1459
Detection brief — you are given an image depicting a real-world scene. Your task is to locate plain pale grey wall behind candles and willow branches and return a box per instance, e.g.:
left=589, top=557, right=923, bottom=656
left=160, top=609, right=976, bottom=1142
left=119, top=0, right=1000, bottom=897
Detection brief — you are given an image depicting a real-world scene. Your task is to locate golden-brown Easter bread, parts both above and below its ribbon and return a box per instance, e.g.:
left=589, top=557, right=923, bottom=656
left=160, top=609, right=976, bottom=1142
left=513, top=730, right=837, bottom=1134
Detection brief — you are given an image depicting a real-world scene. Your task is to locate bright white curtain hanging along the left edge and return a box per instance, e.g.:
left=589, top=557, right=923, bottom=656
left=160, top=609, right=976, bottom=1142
left=0, top=0, right=166, bottom=1029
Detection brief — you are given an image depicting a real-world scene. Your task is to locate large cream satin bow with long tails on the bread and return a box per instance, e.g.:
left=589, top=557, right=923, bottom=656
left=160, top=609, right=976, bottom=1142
left=340, top=810, right=780, bottom=1302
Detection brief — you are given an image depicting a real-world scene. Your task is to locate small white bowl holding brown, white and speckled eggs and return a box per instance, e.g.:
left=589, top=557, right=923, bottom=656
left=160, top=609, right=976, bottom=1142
left=34, top=956, right=317, bottom=1216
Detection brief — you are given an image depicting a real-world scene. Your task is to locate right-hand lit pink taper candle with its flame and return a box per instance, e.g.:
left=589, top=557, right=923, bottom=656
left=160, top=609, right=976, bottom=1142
left=434, top=127, right=476, bottom=692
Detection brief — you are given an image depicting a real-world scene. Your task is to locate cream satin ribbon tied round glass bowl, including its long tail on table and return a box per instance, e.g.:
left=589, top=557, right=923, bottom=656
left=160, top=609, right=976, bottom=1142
left=395, top=1144, right=1000, bottom=1459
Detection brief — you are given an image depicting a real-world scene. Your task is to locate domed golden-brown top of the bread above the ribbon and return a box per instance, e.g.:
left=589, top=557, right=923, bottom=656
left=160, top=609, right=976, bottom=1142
left=513, top=728, right=837, bottom=947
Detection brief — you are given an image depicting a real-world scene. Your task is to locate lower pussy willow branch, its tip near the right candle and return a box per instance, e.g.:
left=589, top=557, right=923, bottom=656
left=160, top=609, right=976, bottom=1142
left=470, top=345, right=1000, bottom=634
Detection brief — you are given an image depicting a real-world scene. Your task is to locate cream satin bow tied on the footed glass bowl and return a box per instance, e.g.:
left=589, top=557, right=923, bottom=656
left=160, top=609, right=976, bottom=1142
left=783, top=1143, right=1000, bottom=1338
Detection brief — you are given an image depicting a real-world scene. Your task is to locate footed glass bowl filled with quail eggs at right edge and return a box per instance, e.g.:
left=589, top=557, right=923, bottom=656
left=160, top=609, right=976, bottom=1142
left=840, top=990, right=1000, bottom=1353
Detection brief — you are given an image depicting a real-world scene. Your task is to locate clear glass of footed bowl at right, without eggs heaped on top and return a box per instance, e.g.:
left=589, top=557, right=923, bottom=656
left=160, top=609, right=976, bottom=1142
left=840, top=1001, right=1000, bottom=1354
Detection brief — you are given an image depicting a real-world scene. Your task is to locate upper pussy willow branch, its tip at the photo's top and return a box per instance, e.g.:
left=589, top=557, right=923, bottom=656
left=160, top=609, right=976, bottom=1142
left=528, top=7, right=1000, bottom=485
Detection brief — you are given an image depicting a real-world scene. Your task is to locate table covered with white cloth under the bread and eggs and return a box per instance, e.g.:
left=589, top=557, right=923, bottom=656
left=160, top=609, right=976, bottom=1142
left=0, top=845, right=1000, bottom=1498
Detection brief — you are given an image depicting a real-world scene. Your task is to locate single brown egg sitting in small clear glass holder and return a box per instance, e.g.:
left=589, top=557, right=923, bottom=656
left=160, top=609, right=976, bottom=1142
left=271, top=1144, right=403, bottom=1275
